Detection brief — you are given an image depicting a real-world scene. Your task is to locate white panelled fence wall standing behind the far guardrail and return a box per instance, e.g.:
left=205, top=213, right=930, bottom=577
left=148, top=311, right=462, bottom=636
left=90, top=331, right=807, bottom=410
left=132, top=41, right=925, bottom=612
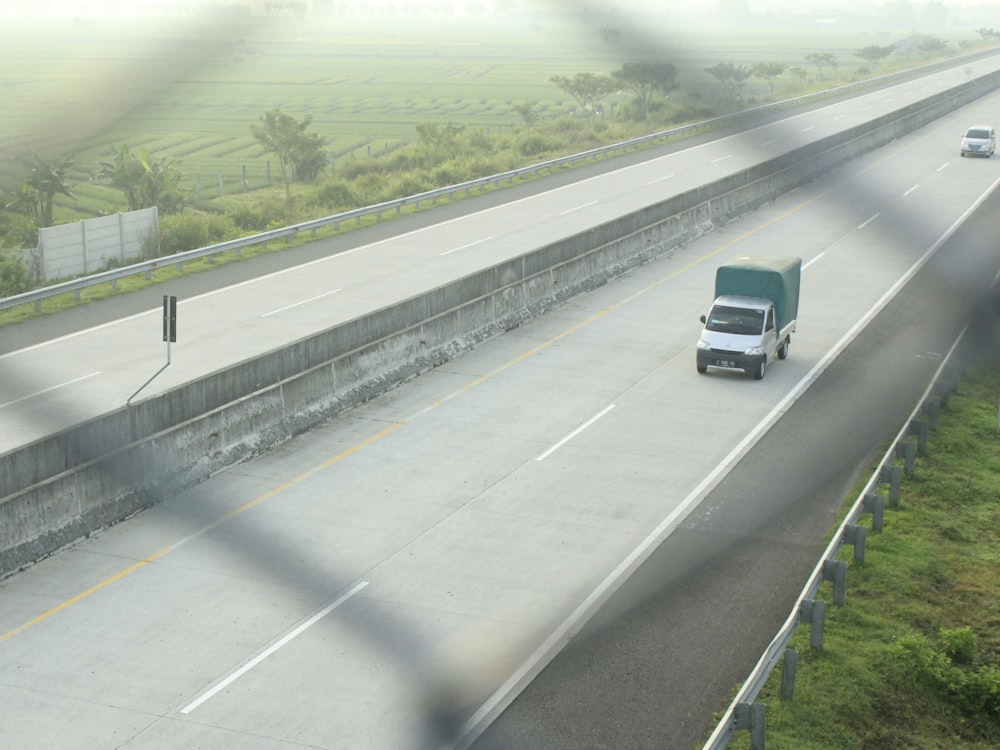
left=37, top=206, right=159, bottom=281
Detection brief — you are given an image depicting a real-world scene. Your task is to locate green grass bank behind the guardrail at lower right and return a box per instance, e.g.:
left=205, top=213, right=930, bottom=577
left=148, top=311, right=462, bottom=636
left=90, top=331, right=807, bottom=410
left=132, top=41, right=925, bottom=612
left=730, top=346, right=1000, bottom=750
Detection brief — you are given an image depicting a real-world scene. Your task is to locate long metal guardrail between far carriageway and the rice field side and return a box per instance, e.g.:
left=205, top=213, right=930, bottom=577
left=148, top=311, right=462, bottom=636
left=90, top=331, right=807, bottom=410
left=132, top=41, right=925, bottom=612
left=0, top=49, right=996, bottom=311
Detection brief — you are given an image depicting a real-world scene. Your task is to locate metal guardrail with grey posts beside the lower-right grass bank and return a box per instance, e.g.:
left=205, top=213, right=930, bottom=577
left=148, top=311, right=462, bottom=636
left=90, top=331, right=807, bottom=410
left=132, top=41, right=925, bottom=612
left=702, top=330, right=965, bottom=750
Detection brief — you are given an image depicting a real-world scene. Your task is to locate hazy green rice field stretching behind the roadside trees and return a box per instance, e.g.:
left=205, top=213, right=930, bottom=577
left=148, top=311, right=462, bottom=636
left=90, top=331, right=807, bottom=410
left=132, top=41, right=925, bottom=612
left=0, top=14, right=975, bottom=220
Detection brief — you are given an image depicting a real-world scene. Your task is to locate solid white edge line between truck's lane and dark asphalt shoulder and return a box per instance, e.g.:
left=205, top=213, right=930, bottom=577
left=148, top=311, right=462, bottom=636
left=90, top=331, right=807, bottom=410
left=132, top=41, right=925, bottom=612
left=454, top=178, right=1000, bottom=750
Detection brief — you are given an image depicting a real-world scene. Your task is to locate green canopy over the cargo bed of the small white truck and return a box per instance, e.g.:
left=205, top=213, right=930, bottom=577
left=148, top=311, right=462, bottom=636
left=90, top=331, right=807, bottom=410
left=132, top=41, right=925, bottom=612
left=715, top=256, right=802, bottom=331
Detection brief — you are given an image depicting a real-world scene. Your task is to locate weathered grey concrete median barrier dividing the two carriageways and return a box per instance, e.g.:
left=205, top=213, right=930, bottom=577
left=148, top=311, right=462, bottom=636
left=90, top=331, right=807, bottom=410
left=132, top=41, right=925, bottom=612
left=0, top=74, right=1000, bottom=576
